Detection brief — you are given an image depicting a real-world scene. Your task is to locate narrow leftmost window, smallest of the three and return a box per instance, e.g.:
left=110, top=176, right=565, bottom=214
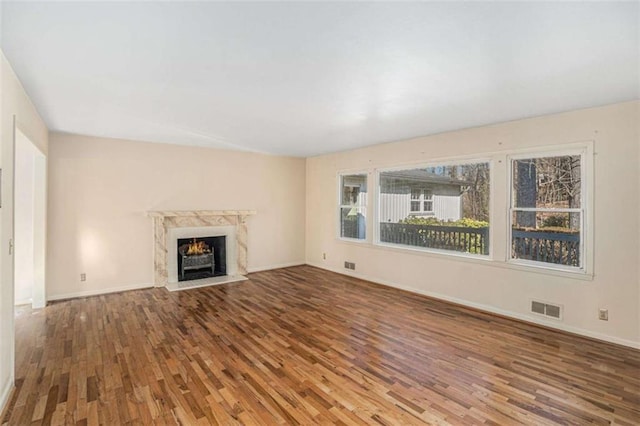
left=340, top=174, right=367, bottom=240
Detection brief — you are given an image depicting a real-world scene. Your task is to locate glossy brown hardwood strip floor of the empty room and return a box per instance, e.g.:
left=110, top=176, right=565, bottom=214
left=3, top=266, right=640, bottom=425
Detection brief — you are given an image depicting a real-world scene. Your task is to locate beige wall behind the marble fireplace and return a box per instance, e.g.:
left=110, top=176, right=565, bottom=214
left=47, top=134, right=305, bottom=299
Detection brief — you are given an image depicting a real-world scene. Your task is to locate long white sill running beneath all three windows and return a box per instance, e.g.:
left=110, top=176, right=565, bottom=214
left=338, top=238, right=594, bottom=281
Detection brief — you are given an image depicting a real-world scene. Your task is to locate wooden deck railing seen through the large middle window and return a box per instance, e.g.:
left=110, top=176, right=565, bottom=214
left=380, top=222, right=489, bottom=254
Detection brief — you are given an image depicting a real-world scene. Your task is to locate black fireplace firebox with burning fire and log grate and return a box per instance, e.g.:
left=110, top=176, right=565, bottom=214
left=177, top=236, right=227, bottom=281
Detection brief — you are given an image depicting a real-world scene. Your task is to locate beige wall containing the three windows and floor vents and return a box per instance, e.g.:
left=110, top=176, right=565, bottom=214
left=306, top=102, right=640, bottom=347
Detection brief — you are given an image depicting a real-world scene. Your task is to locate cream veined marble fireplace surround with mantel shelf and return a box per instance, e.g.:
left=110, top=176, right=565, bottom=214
left=147, top=210, right=256, bottom=287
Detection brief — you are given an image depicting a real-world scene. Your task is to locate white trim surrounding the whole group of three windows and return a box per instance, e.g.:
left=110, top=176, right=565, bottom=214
left=334, top=140, right=595, bottom=281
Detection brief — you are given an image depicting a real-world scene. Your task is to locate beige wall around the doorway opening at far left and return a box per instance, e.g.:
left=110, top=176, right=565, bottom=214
left=0, top=52, right=48, bottom=409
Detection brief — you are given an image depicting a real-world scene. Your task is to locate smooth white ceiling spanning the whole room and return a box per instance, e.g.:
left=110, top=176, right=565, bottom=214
left=2, top=1, right=640, bottom=156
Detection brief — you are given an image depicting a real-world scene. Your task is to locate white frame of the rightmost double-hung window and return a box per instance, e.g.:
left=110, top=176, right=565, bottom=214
left=505, top=144, right=593, bottom=275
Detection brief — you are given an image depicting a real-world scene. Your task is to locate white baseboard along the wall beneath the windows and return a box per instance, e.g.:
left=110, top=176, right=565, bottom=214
left=307, top=262, right=640, bottom=349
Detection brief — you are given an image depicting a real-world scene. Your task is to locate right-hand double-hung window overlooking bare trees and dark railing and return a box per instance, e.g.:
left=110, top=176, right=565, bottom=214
left=509, top=153, right=584, bottom=269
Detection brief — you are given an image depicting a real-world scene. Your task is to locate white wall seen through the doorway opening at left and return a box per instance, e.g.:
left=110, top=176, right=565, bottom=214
left=14, top=133, right=35, bottom=305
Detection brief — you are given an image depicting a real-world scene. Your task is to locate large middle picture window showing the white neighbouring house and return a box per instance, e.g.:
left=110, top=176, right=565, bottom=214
left=377, top=162, right=490, bottom=255
